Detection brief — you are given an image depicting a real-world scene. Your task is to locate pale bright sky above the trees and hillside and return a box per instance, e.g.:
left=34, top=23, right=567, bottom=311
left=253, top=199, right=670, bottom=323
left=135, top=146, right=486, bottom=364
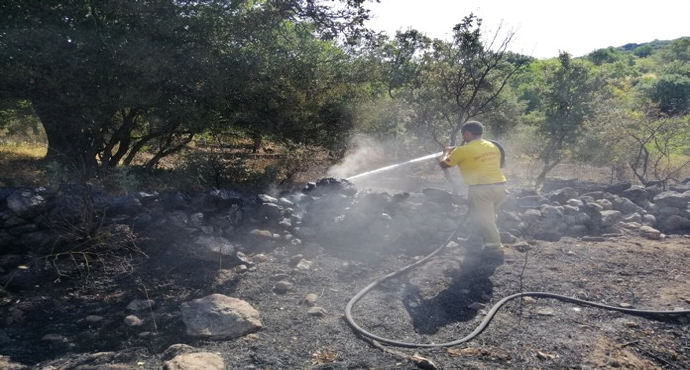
left=368, top=0, right=690, bottom=58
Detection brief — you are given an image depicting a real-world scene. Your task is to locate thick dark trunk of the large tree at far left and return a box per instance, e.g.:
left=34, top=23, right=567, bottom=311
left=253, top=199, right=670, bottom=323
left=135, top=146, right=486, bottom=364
left=33, top=100, right=97, bottom=175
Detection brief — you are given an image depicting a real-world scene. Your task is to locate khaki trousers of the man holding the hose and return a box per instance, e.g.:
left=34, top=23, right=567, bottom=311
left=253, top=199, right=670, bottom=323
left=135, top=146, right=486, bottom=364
left=467, top=184, right=508, bottom=248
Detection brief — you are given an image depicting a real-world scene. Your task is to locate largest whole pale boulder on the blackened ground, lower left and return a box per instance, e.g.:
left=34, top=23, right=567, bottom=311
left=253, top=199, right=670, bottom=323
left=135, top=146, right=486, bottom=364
left=181, top=294, right=262, bottom=339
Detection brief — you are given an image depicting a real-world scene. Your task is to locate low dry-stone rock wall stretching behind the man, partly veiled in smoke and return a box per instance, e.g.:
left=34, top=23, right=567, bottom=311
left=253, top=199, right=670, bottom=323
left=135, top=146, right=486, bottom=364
left=0, top=178, right=690, bottom=290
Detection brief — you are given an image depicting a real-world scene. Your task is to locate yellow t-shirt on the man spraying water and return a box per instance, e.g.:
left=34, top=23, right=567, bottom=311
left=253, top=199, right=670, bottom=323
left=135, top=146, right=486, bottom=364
left=443, top=139, right=506, bottom=185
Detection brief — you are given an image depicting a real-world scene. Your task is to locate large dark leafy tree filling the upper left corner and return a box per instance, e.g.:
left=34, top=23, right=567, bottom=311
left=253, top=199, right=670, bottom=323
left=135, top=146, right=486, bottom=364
left=0, top=0, right=367, bottom=168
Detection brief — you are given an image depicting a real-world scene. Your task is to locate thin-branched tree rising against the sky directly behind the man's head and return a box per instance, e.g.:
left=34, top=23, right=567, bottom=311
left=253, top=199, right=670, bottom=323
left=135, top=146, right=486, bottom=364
left=408, top=14, right=527, bottom=146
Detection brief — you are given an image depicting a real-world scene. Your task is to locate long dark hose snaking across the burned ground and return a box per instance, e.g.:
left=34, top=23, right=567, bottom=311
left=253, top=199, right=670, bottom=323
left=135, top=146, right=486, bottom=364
left=345, top=229, right=690, bottom=348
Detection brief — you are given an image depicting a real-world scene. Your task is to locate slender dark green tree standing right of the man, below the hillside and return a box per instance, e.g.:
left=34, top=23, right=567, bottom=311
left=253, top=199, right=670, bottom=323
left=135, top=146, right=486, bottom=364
left=536, top=53, right=602, bottom=183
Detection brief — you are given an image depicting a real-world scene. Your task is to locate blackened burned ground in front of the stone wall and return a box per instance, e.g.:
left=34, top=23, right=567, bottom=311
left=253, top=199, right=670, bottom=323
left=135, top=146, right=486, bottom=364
left=0, top=227, right=690, bottom=369
